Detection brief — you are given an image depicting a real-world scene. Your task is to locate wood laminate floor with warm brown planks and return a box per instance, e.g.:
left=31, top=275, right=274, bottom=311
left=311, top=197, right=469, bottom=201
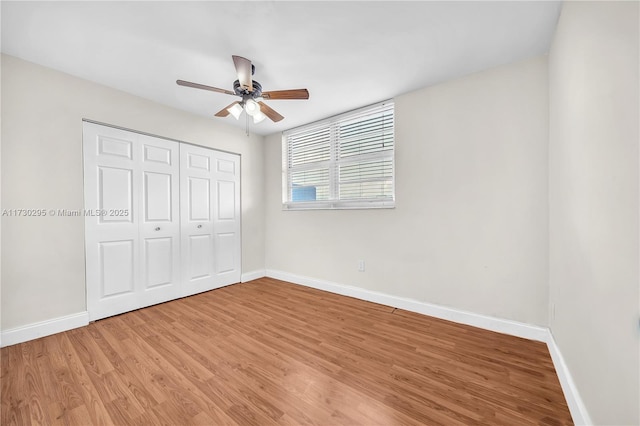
left=0, top=278, right=572, bottom=425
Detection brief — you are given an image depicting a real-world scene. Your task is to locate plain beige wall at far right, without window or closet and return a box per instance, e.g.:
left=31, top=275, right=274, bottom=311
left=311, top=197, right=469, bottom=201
left=549, top=2, right=640, bottom=425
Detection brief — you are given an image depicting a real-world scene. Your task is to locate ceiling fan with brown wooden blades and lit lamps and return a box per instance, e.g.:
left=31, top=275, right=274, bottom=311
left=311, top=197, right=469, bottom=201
left=176, top=55, right=309, bottom=123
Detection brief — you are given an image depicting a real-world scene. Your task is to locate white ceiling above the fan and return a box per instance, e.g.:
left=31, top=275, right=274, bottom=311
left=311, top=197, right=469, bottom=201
left=1, top=1, right=561, bottom=134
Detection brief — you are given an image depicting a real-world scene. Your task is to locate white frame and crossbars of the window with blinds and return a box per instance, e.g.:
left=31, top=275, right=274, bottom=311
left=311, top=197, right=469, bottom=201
left=282, top=99, right=396, bottom=210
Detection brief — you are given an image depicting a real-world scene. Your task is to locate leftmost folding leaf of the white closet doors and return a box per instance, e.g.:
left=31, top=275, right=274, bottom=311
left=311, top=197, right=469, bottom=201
left=83, top=123, right=140, bottom=321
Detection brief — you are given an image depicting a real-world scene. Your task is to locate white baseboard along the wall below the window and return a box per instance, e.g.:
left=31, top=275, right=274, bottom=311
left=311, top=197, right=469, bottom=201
left=266, top=269, right=549, bottom=342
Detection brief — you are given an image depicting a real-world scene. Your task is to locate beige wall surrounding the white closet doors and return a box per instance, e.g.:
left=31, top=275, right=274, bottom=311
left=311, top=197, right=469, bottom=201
left=1, top=56, right=264, bottom=330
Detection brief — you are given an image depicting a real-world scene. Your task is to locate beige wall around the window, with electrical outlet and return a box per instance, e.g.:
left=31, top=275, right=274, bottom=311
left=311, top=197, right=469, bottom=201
left=265, top=57, right=548, bottom=325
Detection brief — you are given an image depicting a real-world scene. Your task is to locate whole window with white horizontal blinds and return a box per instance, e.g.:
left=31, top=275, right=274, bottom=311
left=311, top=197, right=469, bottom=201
left=282, top=101, right=395, bottom=209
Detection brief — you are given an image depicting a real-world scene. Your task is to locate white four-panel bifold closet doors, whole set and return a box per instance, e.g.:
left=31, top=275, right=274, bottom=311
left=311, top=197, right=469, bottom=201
left=83, top=122, right=241, bottom=321
